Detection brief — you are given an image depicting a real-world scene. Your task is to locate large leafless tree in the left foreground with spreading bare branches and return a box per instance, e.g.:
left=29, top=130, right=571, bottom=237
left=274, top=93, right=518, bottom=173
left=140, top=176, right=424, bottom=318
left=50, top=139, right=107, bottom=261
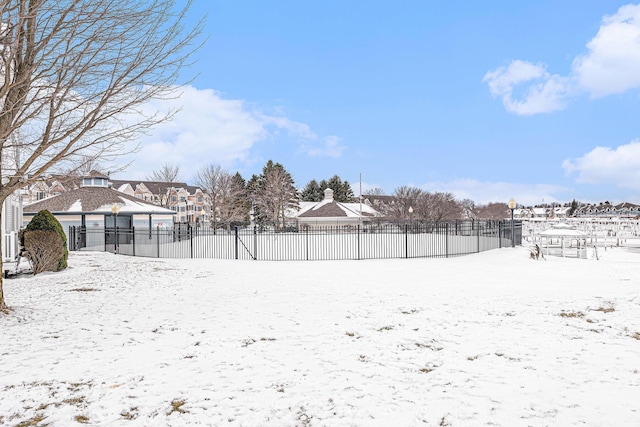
left=0, top=0, right=202, bottom=311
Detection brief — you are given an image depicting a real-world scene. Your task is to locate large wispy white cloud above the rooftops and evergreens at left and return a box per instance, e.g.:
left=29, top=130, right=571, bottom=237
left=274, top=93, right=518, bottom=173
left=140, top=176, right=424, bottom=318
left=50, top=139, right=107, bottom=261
left=115, top=86, right=344, bottom=180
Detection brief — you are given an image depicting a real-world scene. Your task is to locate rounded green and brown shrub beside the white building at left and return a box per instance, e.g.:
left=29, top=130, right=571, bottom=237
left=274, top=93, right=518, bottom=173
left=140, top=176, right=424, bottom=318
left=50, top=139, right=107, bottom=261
left=20, top=210, right=69, bottom=274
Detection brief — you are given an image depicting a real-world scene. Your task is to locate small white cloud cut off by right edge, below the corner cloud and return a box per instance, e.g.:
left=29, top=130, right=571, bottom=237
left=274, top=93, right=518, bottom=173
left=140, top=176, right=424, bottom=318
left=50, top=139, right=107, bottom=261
left=562, top=140, right=640, bottom=190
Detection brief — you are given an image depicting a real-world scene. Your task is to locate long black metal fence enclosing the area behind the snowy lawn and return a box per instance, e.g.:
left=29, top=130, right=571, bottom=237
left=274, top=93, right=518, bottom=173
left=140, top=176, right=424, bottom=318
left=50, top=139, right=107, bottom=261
left=68, top=221, right=522, bottom=261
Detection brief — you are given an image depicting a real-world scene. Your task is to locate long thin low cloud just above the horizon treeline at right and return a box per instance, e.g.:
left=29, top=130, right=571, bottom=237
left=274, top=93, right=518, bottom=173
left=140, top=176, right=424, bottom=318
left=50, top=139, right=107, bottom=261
left=420, top=179, right=570, bottom=205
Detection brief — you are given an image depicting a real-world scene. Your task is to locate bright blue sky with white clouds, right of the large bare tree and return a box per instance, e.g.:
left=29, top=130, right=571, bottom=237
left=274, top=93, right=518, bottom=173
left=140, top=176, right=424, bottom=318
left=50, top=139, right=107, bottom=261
left=112, top=0, right=640, bottom=205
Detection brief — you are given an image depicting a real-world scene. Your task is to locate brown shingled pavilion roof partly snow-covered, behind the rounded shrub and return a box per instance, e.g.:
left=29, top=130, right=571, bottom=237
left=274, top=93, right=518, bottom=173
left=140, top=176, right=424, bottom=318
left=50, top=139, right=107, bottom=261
left=23, top=187, right=174, bottom=215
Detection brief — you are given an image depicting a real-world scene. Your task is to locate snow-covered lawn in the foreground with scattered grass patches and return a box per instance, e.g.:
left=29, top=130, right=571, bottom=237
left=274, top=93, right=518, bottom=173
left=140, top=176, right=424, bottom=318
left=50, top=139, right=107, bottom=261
left=0, top=248, right=640, bottom=426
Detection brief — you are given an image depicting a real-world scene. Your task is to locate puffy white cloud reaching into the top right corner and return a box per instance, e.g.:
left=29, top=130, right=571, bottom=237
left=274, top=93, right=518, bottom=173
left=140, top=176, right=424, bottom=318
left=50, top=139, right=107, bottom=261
left=482, top=4, right=640, bottom=115
